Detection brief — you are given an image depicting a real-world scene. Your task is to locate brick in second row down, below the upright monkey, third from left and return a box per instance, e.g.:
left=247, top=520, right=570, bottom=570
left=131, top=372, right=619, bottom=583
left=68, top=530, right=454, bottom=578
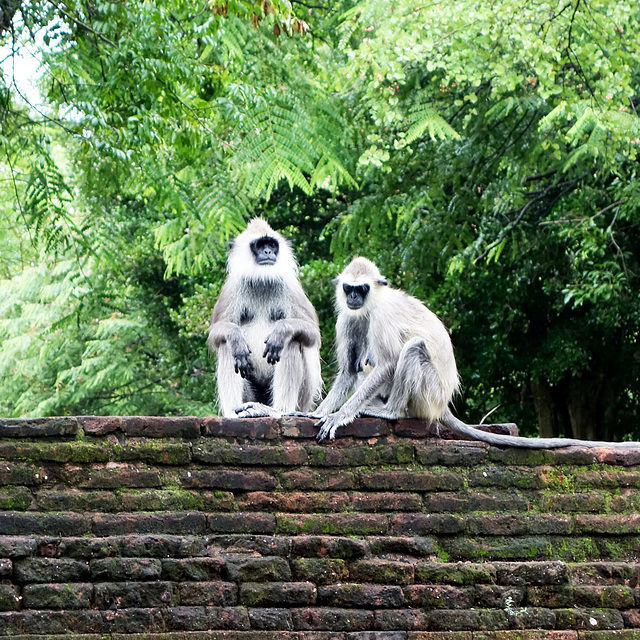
left=193, top=440, right=307, bottom=467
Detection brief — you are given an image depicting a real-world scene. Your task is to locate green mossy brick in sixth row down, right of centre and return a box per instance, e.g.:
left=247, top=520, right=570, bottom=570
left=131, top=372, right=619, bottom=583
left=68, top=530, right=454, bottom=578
left=438, top=536, right=553, bottom=561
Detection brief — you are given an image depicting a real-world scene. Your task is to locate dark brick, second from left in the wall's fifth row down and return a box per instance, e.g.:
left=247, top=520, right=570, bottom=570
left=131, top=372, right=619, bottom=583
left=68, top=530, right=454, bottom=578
left=91, top=512, right=206, bottom=536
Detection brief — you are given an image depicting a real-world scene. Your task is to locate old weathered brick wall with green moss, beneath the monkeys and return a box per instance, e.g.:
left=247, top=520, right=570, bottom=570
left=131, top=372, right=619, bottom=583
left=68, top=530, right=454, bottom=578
left=0, top=417, right=640, bottom=640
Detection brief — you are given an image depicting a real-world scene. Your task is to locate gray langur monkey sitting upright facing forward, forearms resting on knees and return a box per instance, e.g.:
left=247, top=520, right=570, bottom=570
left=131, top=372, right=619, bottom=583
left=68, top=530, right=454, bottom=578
left=208, top=218, right=322, bottom=418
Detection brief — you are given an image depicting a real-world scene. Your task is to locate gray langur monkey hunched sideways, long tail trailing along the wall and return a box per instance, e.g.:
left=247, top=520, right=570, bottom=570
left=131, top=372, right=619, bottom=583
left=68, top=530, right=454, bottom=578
left=313, top=258, right=640, bottom=449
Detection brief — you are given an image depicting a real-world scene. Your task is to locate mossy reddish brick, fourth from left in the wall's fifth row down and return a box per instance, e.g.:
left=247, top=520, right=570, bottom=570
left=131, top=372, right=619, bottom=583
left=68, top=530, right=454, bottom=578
left=277, top=513, right=389, bottom=536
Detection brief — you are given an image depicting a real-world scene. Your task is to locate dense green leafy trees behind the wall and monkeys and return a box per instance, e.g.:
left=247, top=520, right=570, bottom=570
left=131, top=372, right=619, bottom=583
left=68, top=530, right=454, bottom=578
left=0, top=0, right=640, bottom=439
